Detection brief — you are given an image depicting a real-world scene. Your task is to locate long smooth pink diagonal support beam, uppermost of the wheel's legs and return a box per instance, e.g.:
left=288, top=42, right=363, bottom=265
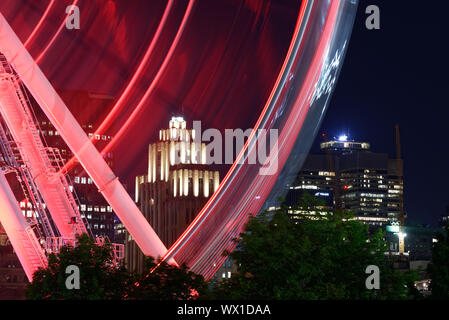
left=0, top=14, right=174, bottom=262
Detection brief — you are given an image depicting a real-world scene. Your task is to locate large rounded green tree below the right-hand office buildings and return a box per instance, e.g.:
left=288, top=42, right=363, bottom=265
left=215, top=194, right=413, bottom=300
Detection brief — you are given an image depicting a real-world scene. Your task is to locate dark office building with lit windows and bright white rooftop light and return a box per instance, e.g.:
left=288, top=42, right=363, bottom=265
left=287, top=137, right=403, bottom=227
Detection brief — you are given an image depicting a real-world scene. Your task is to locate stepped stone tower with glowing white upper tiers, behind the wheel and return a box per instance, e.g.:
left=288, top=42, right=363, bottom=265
left=125, top=117, right=220, bottom=272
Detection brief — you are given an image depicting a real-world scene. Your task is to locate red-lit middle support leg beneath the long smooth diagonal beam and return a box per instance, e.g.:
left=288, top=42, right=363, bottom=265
left=0, top=63, right=87, bottom=238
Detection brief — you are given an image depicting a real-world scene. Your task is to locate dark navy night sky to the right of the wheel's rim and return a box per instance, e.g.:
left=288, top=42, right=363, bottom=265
left=312, top=0, right=449, bottom=225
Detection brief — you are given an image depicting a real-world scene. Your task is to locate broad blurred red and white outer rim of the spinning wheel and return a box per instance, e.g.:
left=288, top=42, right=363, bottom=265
left=159, top=0, right=355, bottom=279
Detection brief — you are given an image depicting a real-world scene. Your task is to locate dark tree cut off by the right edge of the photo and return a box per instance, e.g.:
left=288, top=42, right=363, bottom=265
left=428, top=225, right=449, bottom=299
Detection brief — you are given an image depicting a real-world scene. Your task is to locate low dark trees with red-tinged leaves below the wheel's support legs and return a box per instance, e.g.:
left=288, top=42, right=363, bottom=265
left=26, top=235, right=207, bottom=300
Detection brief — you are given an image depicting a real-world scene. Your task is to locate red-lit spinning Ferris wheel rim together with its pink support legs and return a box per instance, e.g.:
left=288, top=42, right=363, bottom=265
left=0, top=0, right=357, bottom=281
